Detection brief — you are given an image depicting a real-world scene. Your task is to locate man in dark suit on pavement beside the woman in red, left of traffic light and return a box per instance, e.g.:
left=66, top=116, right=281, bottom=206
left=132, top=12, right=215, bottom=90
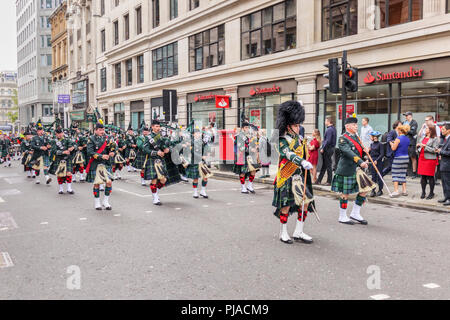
left=317, top=117, right=337, bottom=186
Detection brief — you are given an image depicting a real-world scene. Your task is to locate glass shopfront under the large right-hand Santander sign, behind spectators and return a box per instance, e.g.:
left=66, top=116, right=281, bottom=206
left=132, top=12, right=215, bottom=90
left=317, top=78, right=450, bottom=134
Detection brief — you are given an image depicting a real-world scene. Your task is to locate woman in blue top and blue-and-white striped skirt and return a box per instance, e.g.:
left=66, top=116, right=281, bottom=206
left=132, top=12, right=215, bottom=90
left=390, top=125, right=411, bottom=197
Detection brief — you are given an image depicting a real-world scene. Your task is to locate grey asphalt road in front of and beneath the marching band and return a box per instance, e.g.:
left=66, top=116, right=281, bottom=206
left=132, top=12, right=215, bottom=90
left=0, top=161, right=450, bottom=299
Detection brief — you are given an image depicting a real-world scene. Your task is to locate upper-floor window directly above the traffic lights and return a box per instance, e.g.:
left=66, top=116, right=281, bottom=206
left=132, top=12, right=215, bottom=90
left=322, top=0, right=356, bottom=41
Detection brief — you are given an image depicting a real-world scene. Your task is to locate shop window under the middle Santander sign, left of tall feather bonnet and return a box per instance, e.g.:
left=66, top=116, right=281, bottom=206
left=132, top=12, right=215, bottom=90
left=238, top=93, right=296, bottom=132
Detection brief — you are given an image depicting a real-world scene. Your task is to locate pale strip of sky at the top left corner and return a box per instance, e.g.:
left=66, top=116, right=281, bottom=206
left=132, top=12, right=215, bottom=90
left=0, top=0, right=17, bottom=71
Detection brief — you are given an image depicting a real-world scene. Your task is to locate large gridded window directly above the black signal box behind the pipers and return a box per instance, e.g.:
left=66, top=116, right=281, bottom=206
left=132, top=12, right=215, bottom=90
left=152, top=42, right=178, bottom=80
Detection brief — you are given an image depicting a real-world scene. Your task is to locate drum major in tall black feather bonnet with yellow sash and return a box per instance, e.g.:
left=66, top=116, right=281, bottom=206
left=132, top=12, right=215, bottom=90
left=272, top=101, right=314, bottom=244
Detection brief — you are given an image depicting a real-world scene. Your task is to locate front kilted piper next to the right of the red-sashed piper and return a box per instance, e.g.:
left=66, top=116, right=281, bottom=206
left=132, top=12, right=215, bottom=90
left=141, top=120, right=169, bottom=205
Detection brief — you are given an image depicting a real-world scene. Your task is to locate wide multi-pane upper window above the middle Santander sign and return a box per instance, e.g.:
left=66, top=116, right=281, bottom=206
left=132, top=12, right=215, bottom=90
left=241, top=0, right=297, bottom=60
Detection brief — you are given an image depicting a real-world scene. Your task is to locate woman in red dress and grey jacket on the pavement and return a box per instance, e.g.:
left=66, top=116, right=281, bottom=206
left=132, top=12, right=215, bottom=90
left=416, top=124, right=439, bottom=200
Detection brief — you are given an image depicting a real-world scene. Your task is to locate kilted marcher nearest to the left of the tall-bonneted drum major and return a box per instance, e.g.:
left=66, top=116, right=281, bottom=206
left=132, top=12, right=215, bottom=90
left=233, top=122, right=256, bottom=193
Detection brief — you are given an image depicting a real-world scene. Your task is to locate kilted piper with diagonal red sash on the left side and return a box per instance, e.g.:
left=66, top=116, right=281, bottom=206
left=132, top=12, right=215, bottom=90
left=86, top=119, right=116, bottom=210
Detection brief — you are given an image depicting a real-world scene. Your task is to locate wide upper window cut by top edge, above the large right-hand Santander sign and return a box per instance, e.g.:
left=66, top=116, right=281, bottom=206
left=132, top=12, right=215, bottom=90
left=375, top=0, right=423, bottom=29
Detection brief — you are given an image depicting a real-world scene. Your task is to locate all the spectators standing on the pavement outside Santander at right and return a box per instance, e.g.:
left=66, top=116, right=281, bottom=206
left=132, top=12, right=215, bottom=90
left=309, top=112, right=450, bottom=205
